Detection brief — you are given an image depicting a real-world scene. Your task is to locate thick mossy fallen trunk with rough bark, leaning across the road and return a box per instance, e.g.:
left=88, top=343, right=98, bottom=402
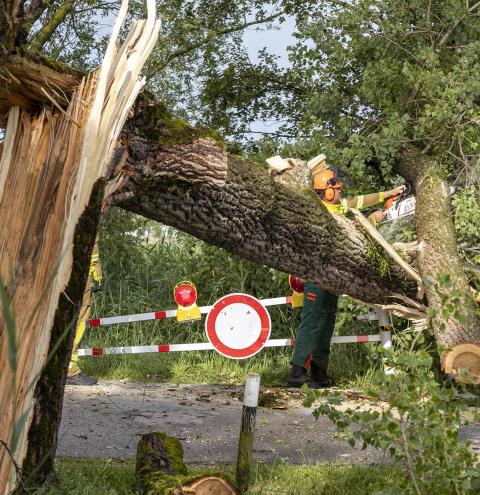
left=112, top=101, right=417, bottom=303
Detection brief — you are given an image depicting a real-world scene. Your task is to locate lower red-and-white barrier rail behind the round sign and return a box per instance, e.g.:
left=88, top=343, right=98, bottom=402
left=78, top=335, right=381, bottom=356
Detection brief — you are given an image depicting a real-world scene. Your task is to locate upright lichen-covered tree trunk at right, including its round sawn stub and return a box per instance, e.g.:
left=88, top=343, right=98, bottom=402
left=399, top=148, right=480, bottom=382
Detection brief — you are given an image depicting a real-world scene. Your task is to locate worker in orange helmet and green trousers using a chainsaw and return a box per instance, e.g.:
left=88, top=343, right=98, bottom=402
left=288, top=157, right=405, bottom=388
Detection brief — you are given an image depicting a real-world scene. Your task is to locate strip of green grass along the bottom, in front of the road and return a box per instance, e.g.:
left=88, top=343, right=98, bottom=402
left=36, top=458, right=390, bottom=495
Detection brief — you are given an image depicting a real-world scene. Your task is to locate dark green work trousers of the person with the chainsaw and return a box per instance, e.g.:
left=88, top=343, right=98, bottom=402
left=291, top=282, right=338, bottom=371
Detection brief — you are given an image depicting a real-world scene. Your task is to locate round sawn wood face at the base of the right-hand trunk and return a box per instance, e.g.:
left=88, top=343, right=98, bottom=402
left=443, top=342, right=480, bottom=384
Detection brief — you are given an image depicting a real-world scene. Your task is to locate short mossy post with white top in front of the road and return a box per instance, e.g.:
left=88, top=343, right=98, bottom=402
left=235, top=373, right=260, bottom=493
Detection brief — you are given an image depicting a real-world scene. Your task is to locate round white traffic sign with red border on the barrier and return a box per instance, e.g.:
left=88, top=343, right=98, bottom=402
left=205, top=294, right=272, bottom=359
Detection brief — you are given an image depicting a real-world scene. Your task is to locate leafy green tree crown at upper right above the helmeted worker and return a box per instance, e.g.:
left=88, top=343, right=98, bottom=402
left=203, top=0, right=480, bottom=188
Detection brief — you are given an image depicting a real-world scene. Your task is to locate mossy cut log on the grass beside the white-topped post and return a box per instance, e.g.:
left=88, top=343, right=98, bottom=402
left=136, top=432, right=239, bottom=495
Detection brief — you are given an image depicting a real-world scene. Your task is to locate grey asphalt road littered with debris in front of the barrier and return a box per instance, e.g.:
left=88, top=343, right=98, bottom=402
left=57, top=382, right=384, bottom=465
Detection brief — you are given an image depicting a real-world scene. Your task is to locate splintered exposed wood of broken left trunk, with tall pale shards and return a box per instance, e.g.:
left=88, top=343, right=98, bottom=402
left=0, top=0, right=159, bottom=495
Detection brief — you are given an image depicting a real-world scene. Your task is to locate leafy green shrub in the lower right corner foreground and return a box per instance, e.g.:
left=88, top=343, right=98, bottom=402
left=306, top=342, right=480, bottom=495
